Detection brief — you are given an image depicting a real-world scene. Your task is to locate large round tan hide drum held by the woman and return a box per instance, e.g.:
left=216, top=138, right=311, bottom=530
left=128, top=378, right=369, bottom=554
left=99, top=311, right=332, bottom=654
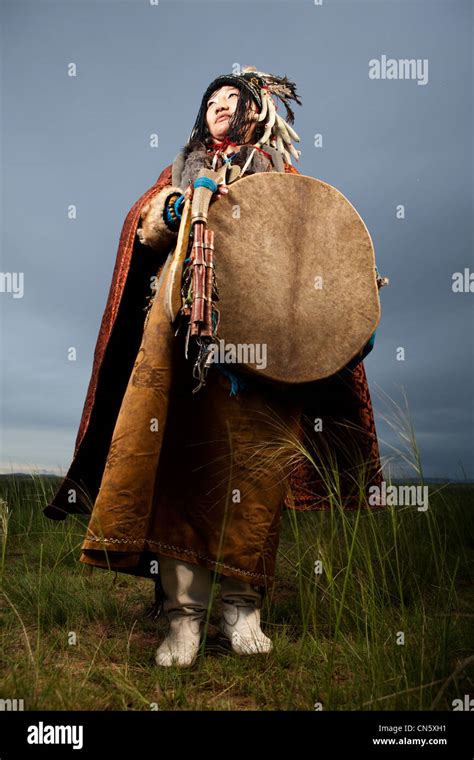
left=208, top=172, right=380, bottom=383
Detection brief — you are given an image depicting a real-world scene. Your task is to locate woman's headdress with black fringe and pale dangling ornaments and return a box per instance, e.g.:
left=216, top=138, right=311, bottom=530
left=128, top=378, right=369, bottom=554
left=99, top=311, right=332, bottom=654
left=189, top=66, right=301, bottom=164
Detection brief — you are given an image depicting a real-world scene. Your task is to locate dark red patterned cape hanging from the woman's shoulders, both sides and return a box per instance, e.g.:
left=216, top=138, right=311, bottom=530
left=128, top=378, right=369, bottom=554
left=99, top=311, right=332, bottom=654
left=44, top=164, right=381, bottom=519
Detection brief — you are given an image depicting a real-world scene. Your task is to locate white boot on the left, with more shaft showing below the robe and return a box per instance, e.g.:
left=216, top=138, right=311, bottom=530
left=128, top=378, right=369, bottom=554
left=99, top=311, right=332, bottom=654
left=155, top=555, right=212, bottom=668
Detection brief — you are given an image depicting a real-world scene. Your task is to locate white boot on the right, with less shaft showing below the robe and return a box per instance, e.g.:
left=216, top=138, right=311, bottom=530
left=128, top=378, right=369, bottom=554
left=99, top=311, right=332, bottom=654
left=220, top=577, right=273, bottom=654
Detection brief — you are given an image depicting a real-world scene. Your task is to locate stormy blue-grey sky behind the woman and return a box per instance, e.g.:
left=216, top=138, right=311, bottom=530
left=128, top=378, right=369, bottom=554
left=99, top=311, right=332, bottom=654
left=0, top=0, right=474, bottom=479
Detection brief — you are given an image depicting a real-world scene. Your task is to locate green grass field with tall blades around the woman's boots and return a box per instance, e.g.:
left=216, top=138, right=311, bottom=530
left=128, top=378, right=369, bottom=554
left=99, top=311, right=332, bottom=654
left=0, top=476, right=474, bottom=711
